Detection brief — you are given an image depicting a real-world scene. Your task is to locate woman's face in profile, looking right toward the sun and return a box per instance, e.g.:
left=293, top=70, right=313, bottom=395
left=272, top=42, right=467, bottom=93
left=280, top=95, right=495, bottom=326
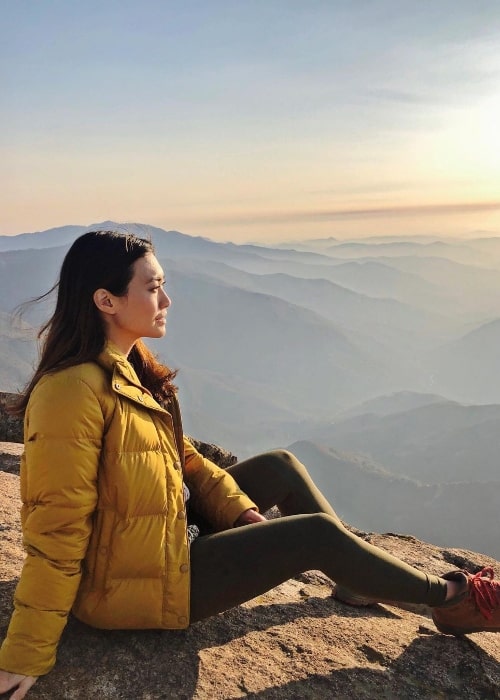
left=102, top=253, right=171, bottom=354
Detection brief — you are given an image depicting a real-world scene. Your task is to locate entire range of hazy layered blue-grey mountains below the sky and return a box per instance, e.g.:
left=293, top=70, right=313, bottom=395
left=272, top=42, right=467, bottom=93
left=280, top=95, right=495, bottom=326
left=0, top=221, right=500, bottom=556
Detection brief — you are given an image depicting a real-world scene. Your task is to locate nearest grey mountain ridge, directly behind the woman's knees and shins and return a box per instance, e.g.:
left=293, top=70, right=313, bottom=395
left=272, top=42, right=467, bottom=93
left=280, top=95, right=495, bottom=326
left=289, top=441, right=500, bottom=557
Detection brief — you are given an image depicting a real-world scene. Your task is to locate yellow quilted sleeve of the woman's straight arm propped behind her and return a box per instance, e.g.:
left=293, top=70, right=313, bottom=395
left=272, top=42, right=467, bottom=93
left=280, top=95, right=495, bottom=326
left=0, top=378, right=104, bottom=676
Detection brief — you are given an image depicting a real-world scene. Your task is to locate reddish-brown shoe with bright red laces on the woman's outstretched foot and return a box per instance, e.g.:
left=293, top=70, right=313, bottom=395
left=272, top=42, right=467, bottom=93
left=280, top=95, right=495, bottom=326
left=432, top=566, right=500, bottom=636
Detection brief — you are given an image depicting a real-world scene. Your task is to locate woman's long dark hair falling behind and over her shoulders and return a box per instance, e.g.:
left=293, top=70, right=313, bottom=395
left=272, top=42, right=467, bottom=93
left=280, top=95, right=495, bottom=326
left=10, top=231, right=176, bottom=415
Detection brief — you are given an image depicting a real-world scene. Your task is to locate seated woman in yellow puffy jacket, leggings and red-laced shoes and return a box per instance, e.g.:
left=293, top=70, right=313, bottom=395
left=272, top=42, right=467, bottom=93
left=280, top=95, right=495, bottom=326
left=0, top=231, right=500, bottom=700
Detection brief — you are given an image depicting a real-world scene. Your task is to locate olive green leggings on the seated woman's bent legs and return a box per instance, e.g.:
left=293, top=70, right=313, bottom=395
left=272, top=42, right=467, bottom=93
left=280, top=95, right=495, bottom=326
left=191, top=450, right=446, bottom=622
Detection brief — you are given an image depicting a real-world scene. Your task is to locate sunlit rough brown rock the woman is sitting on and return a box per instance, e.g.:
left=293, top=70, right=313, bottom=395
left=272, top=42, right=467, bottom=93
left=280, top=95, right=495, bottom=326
left=0, top=444, right=500, bottom=700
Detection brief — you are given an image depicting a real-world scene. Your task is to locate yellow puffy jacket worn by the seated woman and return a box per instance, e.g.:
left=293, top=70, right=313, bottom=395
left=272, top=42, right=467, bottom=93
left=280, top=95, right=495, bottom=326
left=0, top=344, right=256, bottom=676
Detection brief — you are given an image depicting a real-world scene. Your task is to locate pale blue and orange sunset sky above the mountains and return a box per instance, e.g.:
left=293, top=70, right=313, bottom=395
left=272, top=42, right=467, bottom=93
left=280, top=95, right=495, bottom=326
left=0, top=0, right=500, bottom=243
